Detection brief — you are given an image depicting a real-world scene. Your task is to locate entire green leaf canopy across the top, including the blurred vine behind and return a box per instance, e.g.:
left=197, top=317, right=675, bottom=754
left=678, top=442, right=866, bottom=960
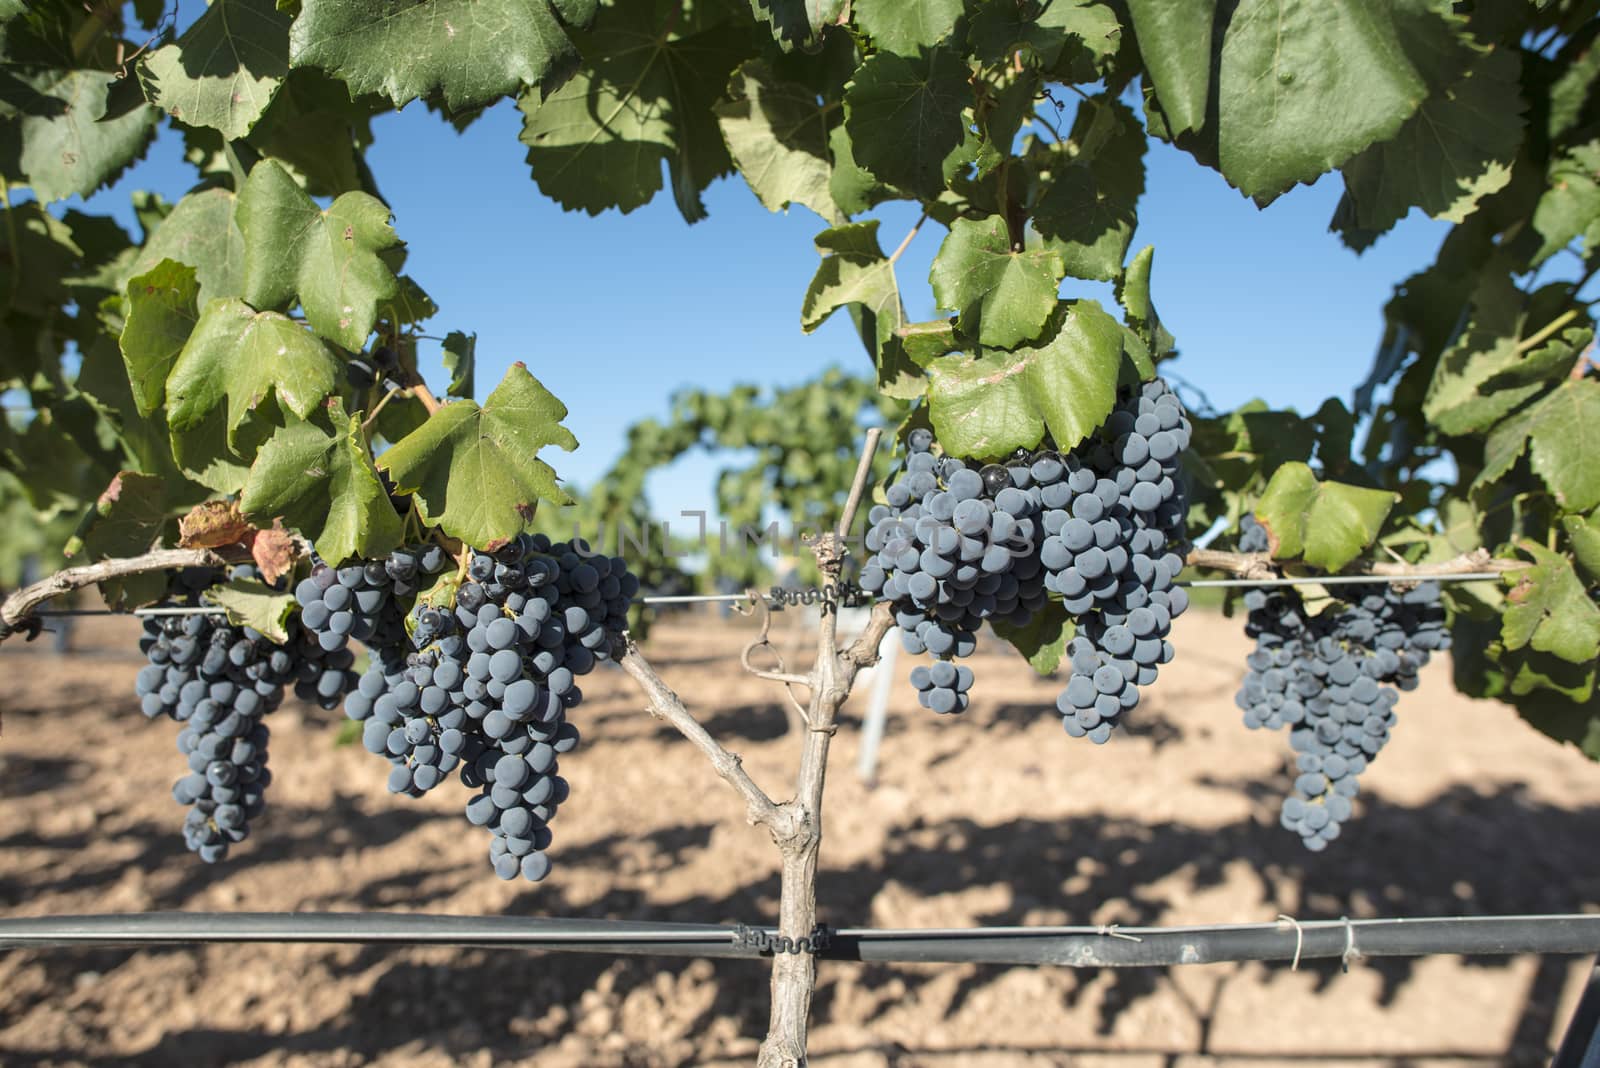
left=0, top=0, right=1600, bottom=1061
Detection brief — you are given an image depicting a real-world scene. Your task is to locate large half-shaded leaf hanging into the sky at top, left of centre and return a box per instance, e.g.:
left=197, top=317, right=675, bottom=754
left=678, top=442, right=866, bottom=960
left=517, top=0, right=750, bottom=222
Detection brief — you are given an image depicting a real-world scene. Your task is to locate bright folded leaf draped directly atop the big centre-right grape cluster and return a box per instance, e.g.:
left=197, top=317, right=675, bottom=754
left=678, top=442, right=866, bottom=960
left=928, top=301, right=1123, bottom=459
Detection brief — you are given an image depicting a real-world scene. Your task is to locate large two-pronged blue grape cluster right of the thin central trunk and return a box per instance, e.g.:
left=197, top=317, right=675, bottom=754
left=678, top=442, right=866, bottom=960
left=861, top=379, right=1190, bottom=742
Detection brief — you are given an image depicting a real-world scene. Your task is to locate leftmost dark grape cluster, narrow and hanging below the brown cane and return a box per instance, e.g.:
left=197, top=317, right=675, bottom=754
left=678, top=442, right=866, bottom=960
left=134, top=568, right=355, bottom=863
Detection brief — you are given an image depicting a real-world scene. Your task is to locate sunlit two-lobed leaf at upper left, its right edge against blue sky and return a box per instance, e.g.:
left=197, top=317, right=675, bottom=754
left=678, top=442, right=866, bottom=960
left=238, top=160, right=400, bottom=350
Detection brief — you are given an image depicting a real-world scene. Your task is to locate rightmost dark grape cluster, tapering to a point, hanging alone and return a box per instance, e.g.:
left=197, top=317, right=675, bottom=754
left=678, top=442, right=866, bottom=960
left=1235, top=516, right=1450, bottom=851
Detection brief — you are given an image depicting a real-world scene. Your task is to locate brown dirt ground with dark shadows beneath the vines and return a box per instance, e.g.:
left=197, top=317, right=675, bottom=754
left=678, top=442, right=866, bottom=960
left=0, top=612, right=1600, bottom=1068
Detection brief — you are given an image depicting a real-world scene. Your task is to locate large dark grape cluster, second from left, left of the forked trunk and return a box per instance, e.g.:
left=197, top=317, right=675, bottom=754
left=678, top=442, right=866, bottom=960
left=298, top=534, right=638, bottom=881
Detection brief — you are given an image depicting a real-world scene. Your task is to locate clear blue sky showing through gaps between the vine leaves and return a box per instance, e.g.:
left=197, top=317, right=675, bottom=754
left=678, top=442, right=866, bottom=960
left=72, top=88, right=1446, bottom=513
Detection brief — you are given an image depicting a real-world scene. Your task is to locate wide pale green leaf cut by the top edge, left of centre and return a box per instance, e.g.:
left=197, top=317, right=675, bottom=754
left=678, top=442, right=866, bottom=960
left=290, top=0, right=598, bottom=110
